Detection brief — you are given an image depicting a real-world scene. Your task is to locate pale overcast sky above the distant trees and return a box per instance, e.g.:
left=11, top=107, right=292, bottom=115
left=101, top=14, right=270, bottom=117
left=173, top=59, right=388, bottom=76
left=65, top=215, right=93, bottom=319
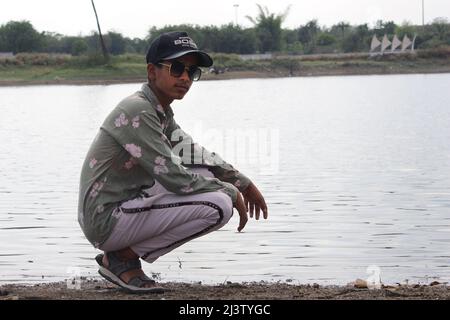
left=0, top=0, right=450, bottom=38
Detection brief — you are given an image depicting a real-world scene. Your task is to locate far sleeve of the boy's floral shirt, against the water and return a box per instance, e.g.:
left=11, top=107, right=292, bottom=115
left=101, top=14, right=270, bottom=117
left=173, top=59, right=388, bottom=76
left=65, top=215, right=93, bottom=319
left=167, top=119, right=251, bottom=192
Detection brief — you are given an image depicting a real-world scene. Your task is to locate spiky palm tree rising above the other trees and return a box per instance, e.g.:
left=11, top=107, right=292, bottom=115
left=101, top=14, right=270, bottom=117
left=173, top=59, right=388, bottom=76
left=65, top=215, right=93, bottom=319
left=246, top=4, right=291, bottom=52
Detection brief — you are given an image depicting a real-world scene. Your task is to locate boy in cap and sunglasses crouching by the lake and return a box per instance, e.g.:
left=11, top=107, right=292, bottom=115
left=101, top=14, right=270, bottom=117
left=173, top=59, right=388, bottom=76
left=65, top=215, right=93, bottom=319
left=78, top=32, right=268, bottom=293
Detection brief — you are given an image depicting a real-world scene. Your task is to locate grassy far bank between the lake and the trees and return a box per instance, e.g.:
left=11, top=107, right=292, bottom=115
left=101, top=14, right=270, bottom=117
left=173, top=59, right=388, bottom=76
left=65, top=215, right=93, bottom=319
left=0, top=47, right=450, bottom=85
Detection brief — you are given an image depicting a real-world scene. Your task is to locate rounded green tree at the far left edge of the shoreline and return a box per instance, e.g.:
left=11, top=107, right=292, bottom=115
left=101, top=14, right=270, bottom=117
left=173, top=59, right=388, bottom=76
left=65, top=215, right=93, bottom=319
left=0, top=21, right=42, bottom=53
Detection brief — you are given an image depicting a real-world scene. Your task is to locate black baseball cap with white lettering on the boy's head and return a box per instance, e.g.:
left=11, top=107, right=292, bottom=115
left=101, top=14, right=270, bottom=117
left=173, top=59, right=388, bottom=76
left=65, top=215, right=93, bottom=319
left=146, top=31, right=213, bottom=67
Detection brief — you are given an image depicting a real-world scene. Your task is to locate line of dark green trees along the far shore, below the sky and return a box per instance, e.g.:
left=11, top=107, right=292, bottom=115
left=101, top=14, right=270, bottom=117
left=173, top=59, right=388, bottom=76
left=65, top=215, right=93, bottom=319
left=0, top=5, right=450, bottom=56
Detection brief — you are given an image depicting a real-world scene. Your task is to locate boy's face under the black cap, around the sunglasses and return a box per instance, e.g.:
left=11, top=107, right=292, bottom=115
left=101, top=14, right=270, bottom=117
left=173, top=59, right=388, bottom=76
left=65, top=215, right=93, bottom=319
left=147, top=54, right=198, bottom=100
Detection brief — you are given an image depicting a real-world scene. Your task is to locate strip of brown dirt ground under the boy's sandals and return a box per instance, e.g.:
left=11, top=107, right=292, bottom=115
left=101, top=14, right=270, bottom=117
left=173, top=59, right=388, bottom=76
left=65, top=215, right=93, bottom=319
left=0, top=279, right=450, bottom=300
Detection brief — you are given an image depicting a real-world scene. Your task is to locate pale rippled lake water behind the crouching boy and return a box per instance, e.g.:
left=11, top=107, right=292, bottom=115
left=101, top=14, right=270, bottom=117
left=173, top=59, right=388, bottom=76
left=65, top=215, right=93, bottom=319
left=0, top=74, right=450, bottom=284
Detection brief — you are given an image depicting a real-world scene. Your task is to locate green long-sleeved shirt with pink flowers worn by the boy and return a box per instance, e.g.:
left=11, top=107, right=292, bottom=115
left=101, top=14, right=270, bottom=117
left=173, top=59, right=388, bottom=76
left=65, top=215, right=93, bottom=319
left=78, top=84, right=250, bottom=247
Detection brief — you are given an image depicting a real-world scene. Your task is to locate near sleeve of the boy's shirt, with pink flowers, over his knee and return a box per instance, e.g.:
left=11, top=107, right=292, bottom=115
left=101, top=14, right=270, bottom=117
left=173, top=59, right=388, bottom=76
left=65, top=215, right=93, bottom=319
left=103, top=109, right=238, bottom=203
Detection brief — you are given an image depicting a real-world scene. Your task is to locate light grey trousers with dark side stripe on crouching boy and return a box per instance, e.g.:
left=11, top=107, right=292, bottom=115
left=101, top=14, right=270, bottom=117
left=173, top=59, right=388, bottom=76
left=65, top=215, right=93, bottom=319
left=100, top=168, right=233, bottom=263
